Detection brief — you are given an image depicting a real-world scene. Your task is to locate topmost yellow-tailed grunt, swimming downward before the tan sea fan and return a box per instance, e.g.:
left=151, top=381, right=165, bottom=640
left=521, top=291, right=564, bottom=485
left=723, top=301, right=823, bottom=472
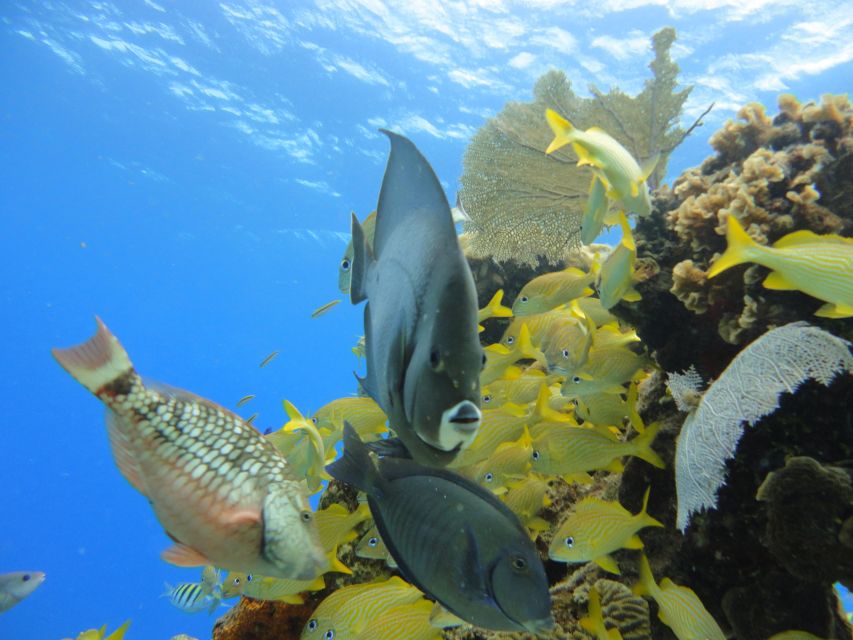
left=545, top=109, right=658, bottom=216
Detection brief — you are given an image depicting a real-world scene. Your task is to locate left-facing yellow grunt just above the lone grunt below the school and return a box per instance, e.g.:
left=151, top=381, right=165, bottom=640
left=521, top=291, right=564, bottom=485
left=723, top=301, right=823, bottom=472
left=530, top=422, right=664, bottom=476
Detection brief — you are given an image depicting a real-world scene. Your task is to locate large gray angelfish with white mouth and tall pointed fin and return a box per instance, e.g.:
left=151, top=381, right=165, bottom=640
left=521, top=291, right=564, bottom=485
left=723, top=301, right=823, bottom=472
left=350, top=131, right=484, bottom=466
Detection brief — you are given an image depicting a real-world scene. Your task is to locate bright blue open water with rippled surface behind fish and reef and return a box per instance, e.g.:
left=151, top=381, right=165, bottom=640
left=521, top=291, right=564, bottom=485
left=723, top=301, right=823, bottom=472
left=0, top=0, right=853, bottom=640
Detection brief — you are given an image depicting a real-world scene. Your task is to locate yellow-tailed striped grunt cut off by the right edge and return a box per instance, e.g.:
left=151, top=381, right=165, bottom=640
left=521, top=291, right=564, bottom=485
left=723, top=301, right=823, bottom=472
left=707, top=215, right=853, bottom=318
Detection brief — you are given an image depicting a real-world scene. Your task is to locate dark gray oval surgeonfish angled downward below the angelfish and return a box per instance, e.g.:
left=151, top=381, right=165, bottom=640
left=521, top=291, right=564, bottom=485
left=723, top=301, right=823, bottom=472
left=326, top=423, right=554, bottom=634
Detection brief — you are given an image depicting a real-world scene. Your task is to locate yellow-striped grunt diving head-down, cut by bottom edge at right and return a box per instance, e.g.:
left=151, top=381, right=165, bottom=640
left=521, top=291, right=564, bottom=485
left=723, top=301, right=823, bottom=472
left=634, top=554, right=726, bottom=640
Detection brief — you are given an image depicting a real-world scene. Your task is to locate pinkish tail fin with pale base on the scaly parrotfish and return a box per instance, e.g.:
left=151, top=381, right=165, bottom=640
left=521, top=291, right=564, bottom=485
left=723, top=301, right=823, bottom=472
left=51, top=316, right=133, bottom=394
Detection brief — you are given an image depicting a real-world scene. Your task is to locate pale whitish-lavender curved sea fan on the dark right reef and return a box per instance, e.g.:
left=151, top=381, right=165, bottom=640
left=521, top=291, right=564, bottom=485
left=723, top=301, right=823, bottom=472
left=675, top=322, right=853, bottom=531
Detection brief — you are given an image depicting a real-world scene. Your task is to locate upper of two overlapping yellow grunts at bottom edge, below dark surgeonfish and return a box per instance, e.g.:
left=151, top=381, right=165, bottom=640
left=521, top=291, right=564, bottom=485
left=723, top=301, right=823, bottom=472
left=300, top=576, right=423, bottom=640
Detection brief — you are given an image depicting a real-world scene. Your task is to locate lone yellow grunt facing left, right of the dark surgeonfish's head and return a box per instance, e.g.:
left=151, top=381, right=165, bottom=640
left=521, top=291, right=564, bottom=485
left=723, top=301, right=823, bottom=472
left=548, top=488, right=663, bottom=573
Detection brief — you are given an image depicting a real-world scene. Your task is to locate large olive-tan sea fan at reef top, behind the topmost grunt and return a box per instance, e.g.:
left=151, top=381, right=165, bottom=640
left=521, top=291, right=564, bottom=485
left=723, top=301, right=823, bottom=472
left=461, top=28, right=690, bottom=266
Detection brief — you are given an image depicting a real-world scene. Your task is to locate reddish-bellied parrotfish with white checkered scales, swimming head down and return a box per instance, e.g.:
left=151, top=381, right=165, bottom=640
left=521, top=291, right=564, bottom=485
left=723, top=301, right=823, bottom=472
left=53, top=319, right=328, bottom=579
